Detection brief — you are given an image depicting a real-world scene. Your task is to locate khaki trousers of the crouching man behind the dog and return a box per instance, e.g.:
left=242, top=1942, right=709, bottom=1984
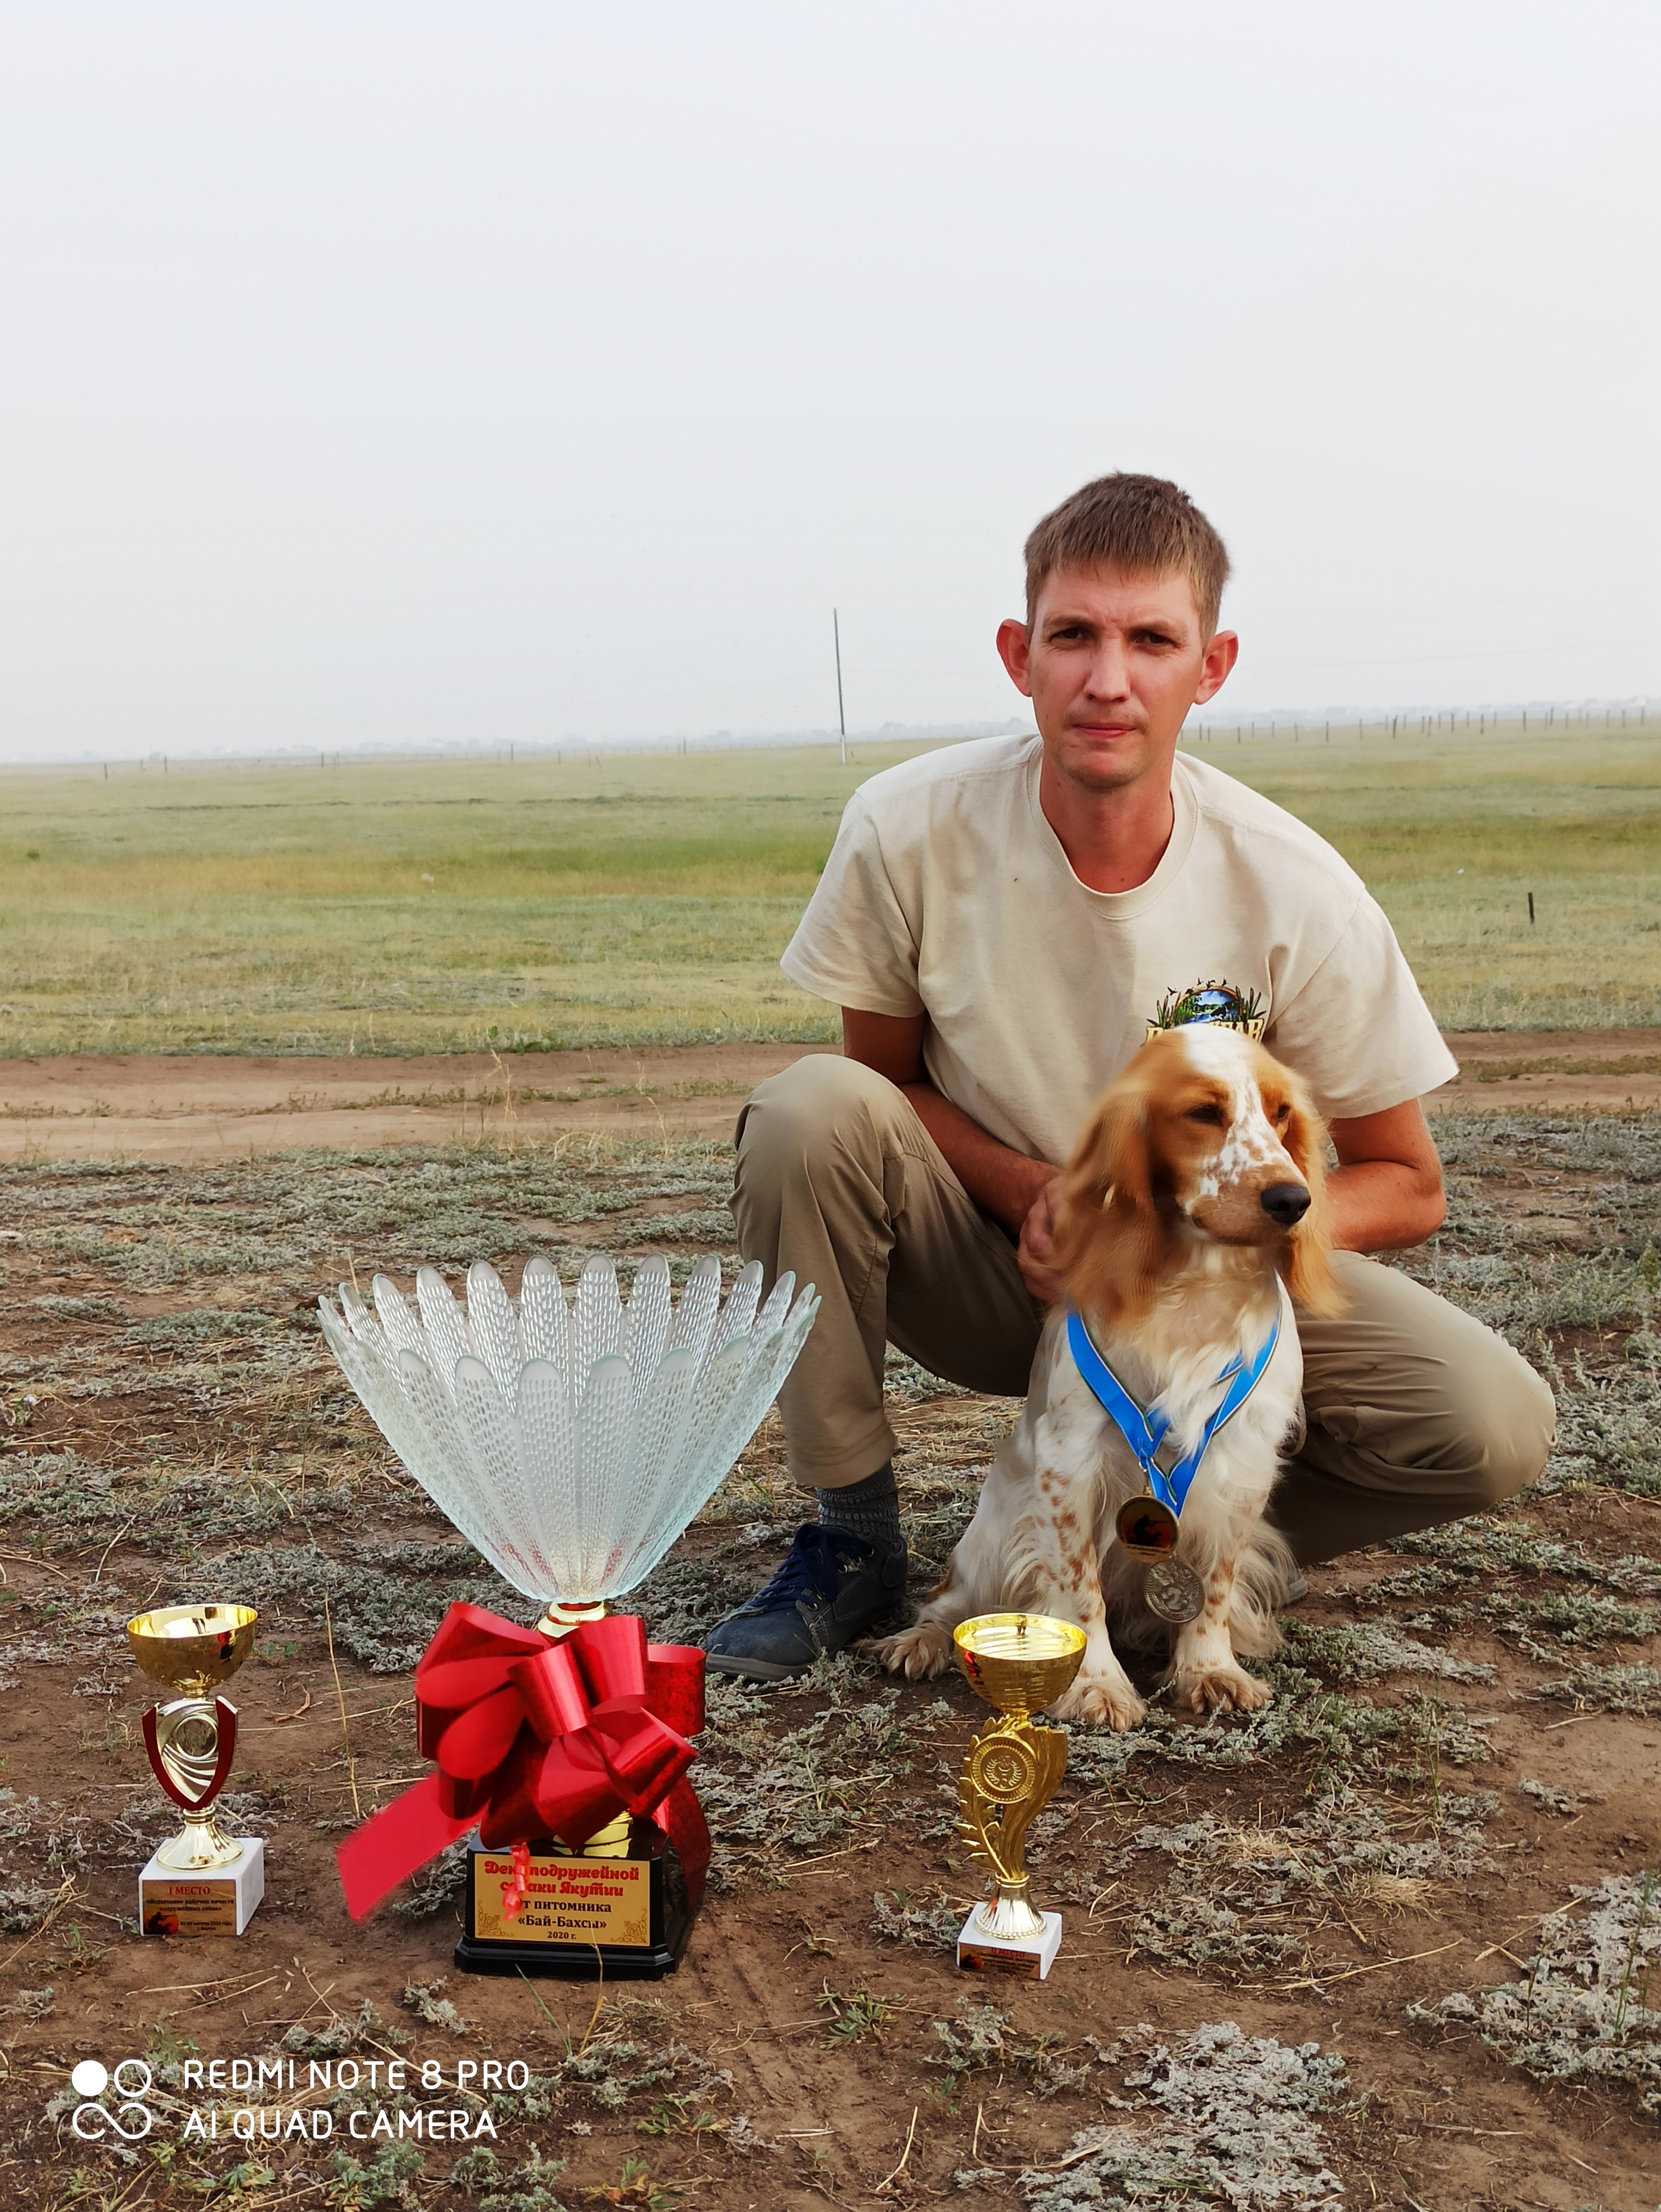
left=732, top=1053, right=1555, bottom=1564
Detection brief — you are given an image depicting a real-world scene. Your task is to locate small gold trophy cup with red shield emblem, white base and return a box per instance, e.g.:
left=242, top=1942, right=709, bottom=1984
left=126, top=1606, right=266, bottom=1936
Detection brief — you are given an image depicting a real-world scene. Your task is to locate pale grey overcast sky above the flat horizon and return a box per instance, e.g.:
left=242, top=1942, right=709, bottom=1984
left=0, top=0, right=1661, bottom=759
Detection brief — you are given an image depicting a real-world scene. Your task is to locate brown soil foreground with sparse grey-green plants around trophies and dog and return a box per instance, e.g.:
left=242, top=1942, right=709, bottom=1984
left=0, top=1123, right=1661, bottom=2212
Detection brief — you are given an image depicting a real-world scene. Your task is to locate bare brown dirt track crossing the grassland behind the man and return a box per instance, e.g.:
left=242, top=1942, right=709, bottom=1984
left=0, top=1029, right=1661, bottom=1159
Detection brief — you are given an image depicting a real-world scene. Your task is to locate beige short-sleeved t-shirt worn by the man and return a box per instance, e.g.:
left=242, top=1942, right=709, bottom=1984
left=781, top=737, right=1458, bottom=1166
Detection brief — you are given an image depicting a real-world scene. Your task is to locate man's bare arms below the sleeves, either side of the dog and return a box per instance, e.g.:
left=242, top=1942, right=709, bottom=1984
left=842, top=1006, right=1447, bottom=1303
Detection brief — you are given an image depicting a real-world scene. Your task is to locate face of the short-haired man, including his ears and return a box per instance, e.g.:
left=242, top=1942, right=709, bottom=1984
left=997, top=568, right=1239, bottom=792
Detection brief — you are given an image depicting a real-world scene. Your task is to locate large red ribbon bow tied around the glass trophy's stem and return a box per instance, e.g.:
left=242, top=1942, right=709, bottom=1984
left=334, top=1606, right=710, bottom=1920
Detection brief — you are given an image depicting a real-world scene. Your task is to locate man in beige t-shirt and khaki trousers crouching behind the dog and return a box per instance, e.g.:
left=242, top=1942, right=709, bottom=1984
left=708, top=476, right=1555, bottom=1681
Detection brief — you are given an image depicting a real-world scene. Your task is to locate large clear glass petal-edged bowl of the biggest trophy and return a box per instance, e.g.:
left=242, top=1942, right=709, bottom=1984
left=319, top=1256, right=819, bottom=1633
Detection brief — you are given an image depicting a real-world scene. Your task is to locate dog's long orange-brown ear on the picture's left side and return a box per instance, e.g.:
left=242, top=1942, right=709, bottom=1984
left=1055, top=1088, right=1165, bottom=1323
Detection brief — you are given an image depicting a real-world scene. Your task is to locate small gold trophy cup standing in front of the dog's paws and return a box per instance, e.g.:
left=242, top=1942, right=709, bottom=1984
left=953, top=1613, right=1084, bottom=1982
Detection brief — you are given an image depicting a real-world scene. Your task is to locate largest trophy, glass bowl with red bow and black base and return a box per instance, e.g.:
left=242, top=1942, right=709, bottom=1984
left=319, top=1256, right=819, bottom=1980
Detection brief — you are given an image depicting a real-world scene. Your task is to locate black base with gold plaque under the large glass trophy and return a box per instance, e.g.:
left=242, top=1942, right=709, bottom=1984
left=455, top=1821, right=695, bottom=1982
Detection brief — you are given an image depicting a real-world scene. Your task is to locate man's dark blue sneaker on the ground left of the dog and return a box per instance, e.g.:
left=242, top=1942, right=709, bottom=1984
left=703, top=1522, right=907, bottom=1681
